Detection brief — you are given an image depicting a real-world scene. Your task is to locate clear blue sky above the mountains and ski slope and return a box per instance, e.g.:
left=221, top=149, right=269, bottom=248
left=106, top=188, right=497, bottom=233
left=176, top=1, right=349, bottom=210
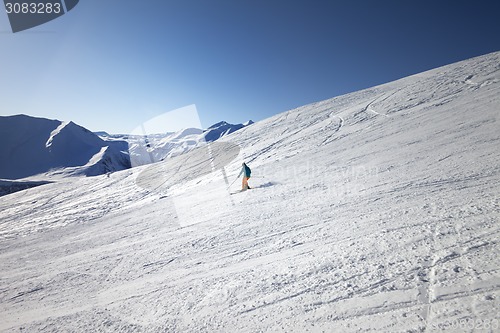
left=0, top=0, right=500, bottom=133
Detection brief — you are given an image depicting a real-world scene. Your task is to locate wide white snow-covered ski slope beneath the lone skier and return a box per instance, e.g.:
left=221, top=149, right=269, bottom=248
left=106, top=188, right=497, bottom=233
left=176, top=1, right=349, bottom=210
left=0, top=53, right=500, bottom=332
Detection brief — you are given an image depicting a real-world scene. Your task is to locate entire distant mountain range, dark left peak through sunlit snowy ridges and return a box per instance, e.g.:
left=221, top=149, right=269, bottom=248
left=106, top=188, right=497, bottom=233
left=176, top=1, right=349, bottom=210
left=0, top=115, right=252, bottom=179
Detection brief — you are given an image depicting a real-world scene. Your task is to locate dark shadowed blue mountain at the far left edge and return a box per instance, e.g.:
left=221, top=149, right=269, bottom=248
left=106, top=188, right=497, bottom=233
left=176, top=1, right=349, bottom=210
left=0, top=115, right=130, bottom=179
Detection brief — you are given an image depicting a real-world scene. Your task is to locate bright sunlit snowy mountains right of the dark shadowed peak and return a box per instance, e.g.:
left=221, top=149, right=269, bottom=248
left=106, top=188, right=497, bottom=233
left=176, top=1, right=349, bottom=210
left=97, top=120, right=253, bottom=167
